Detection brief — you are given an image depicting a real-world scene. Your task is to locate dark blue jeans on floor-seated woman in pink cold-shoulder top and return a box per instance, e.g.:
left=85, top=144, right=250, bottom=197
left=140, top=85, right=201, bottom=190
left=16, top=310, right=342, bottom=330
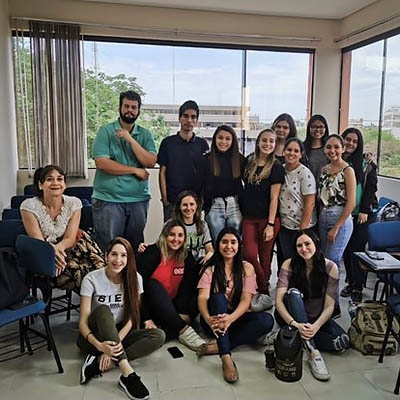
left=200, top=293, right=274, bottom=356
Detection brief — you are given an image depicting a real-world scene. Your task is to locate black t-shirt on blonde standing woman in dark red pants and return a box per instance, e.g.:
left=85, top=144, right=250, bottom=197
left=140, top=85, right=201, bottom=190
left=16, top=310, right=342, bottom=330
left=240, top=156, right=285, bottom=219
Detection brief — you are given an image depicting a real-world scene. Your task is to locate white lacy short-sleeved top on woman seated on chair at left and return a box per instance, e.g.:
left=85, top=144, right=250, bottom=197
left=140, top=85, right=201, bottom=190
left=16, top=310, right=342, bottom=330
left=20, top=195, right=82, bottom=243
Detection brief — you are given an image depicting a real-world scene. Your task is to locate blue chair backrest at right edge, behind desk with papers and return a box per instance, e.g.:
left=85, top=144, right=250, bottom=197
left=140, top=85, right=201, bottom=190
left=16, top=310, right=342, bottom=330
left=368, top=221, right=400, bottom=251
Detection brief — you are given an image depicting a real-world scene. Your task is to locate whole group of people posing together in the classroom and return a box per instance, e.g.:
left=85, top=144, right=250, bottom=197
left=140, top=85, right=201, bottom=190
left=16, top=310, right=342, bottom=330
left=21, top=91, right=377, bottom=399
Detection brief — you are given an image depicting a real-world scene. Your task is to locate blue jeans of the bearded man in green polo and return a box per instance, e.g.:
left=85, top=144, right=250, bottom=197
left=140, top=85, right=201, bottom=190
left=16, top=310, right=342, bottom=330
left=92, top=199, right=149, bottom=252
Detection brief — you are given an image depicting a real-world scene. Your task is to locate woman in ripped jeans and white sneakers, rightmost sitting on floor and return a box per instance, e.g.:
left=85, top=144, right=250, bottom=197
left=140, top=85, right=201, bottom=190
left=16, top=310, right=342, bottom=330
left=275, top=229, right=350, bottom=381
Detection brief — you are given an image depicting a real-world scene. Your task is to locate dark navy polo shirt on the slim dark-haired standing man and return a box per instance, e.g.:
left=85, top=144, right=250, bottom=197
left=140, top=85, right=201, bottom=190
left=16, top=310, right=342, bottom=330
left=157, top=133, right=208, bottom=203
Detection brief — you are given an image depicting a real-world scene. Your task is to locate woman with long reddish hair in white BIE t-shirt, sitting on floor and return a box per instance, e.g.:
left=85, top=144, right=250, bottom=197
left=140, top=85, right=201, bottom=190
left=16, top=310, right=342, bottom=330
left=77, top=237, right=165, bottom=399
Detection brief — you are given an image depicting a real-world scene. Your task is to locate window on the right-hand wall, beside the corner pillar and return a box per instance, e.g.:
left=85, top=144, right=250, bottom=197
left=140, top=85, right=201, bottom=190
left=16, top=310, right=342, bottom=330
left=341, top=28, right=400, bottom=178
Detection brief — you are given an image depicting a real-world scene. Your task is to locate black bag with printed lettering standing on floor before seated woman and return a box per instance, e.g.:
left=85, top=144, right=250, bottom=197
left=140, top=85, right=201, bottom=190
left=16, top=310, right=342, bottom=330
left=275, top=325, right=303, bottom=382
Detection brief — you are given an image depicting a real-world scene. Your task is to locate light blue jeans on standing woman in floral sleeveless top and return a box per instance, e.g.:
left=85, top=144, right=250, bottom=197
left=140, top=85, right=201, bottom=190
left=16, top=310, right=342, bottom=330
left=319, top=206, right=353, bottom=273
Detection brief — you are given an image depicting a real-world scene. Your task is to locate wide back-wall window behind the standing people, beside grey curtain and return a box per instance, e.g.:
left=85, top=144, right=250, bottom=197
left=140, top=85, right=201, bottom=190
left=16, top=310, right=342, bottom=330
left=11, top=32, right=312, bottom=168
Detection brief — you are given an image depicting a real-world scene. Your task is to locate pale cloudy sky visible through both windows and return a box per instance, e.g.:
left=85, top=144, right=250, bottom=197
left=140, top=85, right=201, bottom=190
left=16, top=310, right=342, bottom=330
left=84, top=35, right=400, bottom=124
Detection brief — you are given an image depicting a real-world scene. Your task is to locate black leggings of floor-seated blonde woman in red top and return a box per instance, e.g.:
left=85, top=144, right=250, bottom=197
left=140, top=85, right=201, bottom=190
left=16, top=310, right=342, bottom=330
left=144, top=279, right=198, bottom=339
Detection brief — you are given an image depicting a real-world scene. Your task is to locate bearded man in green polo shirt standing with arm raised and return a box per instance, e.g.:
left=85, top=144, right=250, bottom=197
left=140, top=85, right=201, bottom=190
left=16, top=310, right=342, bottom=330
left=92, top=90, right=157, bottom=251
